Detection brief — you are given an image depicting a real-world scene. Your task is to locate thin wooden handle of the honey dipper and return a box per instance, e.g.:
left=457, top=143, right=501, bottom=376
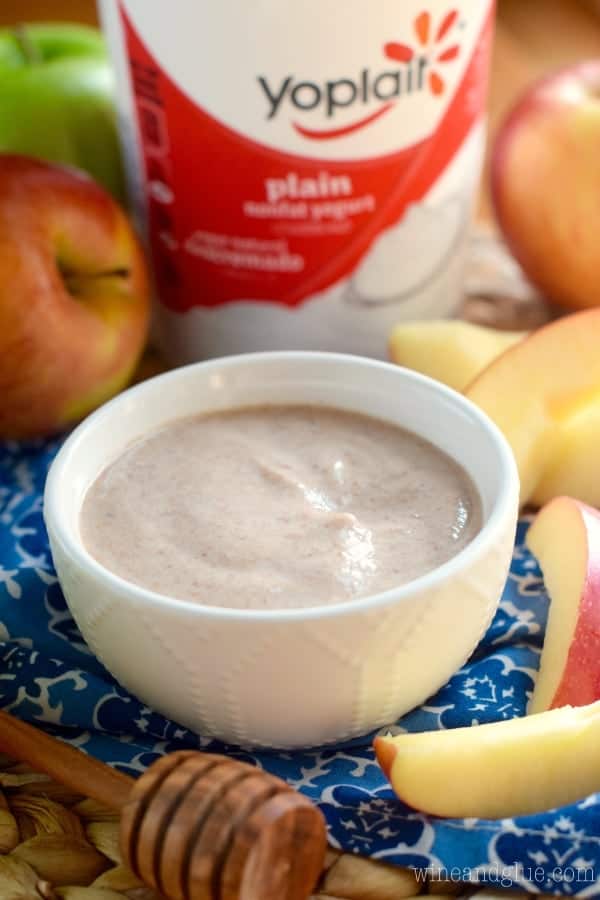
left=0, top=710, right=134, bottom=810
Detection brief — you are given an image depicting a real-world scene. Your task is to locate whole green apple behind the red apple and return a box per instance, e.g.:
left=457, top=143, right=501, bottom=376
left=0, top=23, right=125, bottom=201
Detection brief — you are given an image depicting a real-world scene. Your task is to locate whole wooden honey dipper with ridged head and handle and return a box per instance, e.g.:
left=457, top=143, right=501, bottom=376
left=0, top=710, right=326, bottom=900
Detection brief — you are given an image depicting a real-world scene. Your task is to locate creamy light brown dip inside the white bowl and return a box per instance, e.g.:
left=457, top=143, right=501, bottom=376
left=81, top=406, right=481, bottom=609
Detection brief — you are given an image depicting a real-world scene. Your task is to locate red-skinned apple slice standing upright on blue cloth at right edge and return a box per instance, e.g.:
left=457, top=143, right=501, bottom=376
left=527, top=497, right=600, bottom=713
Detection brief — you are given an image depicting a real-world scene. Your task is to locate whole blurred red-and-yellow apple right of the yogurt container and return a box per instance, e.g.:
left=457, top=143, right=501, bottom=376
left=491, top=60, right=600, bottom=309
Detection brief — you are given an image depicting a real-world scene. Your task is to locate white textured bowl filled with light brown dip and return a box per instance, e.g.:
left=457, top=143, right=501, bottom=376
left=45, top=352, right=518, bottom=748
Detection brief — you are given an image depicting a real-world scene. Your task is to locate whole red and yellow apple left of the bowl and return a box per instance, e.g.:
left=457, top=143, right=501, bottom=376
left=0, top=155, right=149, bottom=438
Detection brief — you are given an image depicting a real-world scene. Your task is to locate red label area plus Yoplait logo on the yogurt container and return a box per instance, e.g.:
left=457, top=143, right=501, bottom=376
left=122, top=8, right=492, bottom=311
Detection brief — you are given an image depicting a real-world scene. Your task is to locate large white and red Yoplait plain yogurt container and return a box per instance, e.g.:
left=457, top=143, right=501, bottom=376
left=100, top=0, right=494, bottom=362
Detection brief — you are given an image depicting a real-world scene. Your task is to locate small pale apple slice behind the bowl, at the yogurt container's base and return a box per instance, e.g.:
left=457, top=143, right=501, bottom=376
left=389, top=319, right=528, bottom=391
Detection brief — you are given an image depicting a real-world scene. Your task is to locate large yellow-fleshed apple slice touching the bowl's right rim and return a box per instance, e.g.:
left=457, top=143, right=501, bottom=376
left=465, top=309, right=600, bottom=505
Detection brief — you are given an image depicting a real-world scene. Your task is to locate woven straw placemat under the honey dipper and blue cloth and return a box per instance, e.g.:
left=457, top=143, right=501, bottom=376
left=0, top=755, right=506, bottom=900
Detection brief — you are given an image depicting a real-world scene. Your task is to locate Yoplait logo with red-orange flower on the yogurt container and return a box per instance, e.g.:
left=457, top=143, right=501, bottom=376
left=258, top=9, right=461, bottom=140
